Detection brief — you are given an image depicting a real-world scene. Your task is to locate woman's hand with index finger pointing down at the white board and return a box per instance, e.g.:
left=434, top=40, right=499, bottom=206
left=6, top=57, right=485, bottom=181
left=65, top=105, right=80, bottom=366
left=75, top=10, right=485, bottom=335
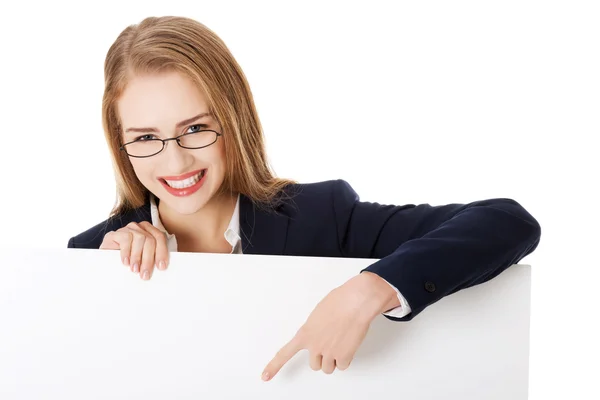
left=262, top=271, right=400, bottom=381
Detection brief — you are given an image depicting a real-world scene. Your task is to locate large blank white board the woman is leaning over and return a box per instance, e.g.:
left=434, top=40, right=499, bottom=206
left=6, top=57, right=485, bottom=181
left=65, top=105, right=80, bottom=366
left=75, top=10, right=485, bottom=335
left=0, top=249, right=531, bottom=400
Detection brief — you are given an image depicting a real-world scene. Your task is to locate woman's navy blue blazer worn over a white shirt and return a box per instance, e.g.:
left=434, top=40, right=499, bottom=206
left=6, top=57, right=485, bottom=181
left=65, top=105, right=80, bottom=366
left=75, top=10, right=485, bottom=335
left=68, top=180, right=541, bottom=321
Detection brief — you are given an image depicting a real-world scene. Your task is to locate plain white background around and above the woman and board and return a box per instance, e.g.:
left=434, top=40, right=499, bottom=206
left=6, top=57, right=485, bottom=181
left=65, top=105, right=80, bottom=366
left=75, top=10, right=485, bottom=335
left=0, top=0, right=600, bottom=400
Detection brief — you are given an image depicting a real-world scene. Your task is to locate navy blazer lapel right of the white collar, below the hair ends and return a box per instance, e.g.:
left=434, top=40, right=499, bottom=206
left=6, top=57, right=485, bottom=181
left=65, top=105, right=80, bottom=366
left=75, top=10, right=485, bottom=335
left=240, top=194, right=289, bottom=255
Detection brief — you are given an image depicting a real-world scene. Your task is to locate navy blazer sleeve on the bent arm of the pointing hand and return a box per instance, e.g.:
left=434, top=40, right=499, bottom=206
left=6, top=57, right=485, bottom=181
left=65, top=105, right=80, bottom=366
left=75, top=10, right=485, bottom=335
left=332, top=180, right=541, bottom=321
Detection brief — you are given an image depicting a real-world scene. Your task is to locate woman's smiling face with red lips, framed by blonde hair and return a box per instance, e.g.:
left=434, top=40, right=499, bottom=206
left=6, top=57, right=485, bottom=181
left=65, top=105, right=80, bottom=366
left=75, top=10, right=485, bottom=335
left=118, top=72, right=226, bottom=214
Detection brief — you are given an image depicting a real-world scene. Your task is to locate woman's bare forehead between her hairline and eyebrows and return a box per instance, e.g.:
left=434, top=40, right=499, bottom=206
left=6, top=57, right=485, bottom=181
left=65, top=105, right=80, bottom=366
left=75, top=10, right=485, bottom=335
left=117, top=72, right=209, bottom=129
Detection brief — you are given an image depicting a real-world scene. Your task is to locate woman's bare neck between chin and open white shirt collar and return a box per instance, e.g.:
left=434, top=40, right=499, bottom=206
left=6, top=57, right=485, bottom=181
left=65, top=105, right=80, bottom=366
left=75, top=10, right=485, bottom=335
left=158, top=193, right=238, bottom=242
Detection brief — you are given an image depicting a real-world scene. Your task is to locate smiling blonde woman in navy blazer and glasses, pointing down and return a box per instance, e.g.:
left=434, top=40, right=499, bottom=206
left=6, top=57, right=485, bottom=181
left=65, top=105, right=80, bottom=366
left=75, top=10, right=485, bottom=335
left=68, top=17, right=541, bottom=380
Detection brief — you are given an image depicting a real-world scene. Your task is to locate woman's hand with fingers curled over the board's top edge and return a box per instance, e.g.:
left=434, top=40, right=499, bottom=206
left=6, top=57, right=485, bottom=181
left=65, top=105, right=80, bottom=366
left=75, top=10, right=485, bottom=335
left=100, top=221, right=169, bottom=280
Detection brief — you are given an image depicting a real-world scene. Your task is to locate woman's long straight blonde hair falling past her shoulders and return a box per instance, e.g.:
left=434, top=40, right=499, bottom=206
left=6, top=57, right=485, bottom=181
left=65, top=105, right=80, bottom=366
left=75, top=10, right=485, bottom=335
left=102, top=16, right=296, bottom=216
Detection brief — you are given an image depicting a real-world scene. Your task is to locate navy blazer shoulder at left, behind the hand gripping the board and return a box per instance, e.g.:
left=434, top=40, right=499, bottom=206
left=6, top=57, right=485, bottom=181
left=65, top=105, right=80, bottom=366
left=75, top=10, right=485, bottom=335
left=67, top=206, right=152, bottom=249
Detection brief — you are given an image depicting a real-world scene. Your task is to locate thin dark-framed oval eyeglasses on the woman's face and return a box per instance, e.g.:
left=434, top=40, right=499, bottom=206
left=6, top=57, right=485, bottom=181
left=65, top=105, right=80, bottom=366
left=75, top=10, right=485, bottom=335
left=120, top=130, right=223, bottom=158
